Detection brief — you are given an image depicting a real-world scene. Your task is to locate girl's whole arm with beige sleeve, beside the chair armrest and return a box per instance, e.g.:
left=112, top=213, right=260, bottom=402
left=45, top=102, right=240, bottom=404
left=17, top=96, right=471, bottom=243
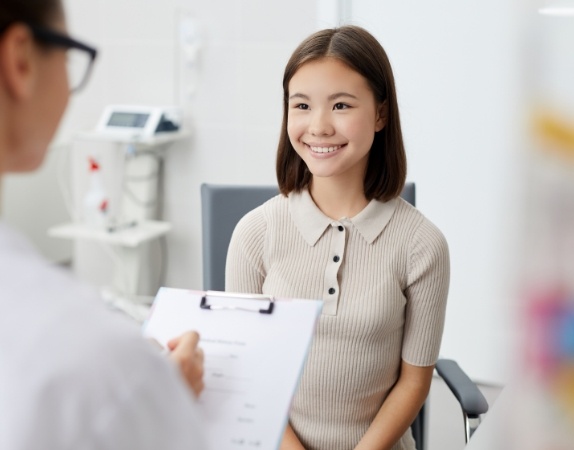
left=355, top=216, right=450, bottom=450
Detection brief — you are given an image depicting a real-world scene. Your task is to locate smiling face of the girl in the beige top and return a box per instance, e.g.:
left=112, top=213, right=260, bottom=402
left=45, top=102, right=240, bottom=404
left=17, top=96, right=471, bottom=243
left=287, top=57, right=385, bottom=186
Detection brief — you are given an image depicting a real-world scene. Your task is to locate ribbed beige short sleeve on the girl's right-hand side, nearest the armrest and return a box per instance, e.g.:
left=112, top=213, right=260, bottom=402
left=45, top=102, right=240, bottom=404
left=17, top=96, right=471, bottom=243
left=402, top=218, right=450, bottom=366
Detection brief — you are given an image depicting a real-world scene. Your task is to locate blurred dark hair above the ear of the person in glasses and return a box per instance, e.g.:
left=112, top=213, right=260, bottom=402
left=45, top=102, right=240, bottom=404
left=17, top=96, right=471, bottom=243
left=0, top=0, right=64, bottom=32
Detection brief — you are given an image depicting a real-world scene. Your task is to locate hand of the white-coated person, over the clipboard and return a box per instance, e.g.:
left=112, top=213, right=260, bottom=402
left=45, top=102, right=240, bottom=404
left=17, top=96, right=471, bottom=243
left=167, top=331, right=204, bottom=396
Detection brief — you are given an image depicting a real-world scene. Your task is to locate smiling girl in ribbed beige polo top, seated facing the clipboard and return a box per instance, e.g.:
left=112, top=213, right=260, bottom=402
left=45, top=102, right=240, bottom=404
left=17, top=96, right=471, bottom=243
left=226, top=26, right=449, bottom=450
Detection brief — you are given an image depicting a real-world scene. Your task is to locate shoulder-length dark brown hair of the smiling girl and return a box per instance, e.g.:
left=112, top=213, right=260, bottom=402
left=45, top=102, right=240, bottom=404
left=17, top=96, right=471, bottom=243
left=276, top=25, right=407, bottom=201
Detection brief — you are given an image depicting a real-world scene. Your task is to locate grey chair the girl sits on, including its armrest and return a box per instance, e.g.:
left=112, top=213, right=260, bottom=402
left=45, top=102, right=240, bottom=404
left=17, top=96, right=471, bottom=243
left=201, top=183, right=488, bottom=450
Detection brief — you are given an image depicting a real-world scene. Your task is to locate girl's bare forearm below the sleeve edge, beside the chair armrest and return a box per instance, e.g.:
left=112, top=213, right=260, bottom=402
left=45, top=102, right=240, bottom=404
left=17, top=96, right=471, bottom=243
left=354, top=361, right=434, bottom=450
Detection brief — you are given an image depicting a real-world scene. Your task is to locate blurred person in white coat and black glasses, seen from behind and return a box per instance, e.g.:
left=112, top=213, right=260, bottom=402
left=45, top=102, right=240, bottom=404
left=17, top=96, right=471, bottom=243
left=0, top=0, right=205, bottom=450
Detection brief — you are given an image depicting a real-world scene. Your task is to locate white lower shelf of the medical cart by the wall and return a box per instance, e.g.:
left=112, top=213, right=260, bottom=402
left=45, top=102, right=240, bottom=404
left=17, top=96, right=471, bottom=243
left=48, top=220, right=172, bottom=248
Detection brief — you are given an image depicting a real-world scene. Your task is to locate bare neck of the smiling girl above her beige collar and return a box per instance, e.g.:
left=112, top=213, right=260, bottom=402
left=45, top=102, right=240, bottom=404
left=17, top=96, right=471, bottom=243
left=309, top=177, right=369, bottom=220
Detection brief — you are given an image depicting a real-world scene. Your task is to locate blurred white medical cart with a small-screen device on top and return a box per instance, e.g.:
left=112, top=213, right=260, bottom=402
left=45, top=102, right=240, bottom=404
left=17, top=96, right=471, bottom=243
left=49, top=105, right=189, bottom=306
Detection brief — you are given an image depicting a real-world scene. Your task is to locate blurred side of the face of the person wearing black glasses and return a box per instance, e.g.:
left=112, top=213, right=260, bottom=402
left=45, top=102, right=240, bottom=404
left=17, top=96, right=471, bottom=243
left=4, top=14, right=69, bottom=172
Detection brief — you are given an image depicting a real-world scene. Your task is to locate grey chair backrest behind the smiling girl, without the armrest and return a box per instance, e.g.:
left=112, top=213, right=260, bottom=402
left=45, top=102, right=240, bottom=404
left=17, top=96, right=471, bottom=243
left=201, top=183, right=426, bottom=450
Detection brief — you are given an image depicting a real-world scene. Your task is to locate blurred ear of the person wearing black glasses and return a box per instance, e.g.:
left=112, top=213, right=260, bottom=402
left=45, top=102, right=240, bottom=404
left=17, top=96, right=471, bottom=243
left=0, top=24, right=36, bottom=100
